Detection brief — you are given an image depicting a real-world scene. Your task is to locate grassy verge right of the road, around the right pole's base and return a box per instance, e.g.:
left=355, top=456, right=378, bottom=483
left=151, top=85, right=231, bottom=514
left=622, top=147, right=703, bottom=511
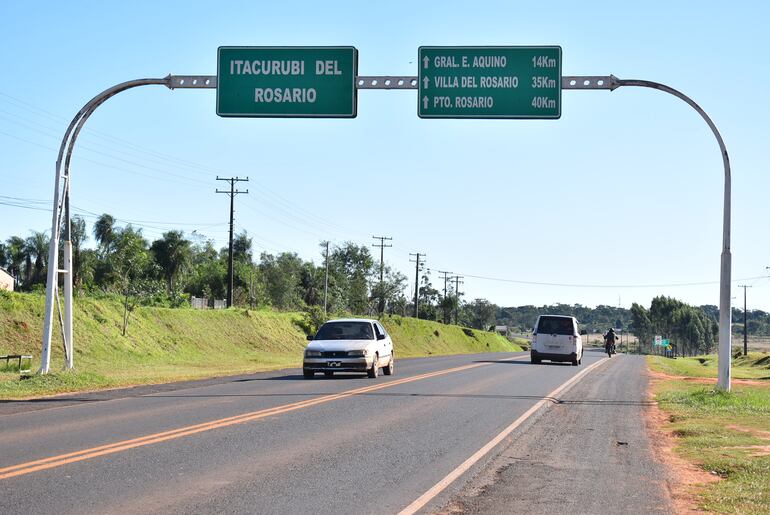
left=649, top=353, right=770, bottom=513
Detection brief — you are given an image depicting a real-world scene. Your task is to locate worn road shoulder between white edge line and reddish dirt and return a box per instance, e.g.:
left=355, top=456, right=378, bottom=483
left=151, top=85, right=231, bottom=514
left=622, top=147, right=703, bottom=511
left=441, top=356, right=673, bottom=514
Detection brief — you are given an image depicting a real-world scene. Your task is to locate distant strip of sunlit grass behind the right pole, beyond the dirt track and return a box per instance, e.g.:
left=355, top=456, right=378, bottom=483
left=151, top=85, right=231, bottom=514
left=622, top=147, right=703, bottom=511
left=649, top=352, right=770, bottom=380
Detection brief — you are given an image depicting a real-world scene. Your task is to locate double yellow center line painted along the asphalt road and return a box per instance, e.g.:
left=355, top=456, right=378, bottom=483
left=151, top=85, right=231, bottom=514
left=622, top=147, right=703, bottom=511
left=0, top=357, right=525, bottom=480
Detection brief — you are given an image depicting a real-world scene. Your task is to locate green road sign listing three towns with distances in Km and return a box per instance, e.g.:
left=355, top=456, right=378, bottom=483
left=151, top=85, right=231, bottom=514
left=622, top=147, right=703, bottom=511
left=417, top=46, right=561, bottom=119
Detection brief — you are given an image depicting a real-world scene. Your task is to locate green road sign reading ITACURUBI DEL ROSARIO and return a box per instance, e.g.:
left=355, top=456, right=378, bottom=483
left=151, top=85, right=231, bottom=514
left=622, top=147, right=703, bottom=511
left=217, top=47, right=358, bottom=118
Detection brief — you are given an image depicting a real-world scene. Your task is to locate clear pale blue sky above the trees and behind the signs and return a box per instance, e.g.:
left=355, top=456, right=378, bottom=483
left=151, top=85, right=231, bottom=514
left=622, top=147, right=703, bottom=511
left=0, top=1, right=770, bottom=311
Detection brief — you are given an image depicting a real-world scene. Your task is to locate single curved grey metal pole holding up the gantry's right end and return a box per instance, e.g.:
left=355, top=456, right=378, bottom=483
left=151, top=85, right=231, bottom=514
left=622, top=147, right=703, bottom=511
left=610, top=77, right=732, bottom=391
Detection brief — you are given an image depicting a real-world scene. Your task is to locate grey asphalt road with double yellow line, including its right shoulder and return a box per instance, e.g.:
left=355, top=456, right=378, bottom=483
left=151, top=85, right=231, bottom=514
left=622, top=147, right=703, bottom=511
left=0, top=352, right=668, bottom=514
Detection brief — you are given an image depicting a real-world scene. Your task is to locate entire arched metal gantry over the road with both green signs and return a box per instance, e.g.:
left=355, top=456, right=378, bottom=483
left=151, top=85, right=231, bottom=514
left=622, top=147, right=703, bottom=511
left=40, top=46, right=732, bottom=390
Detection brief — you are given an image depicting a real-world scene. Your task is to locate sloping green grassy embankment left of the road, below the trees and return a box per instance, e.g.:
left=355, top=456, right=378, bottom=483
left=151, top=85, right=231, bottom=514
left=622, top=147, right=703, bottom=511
left=0, top=292, right=520, bottom=399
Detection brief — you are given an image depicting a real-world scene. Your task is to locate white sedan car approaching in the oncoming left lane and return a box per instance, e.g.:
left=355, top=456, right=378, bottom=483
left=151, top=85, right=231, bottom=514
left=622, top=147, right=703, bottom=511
left=302, top=318, right=395, bottom=379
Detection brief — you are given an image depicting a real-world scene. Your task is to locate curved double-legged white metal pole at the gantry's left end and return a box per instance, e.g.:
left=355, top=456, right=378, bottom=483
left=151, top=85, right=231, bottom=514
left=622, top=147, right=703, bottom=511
left=39, top=75, right=173, bottom=374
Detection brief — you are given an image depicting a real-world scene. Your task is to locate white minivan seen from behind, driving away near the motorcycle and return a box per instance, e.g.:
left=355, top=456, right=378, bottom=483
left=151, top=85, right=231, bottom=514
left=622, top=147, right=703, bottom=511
left=530, top=315, right=583, bottom=366
